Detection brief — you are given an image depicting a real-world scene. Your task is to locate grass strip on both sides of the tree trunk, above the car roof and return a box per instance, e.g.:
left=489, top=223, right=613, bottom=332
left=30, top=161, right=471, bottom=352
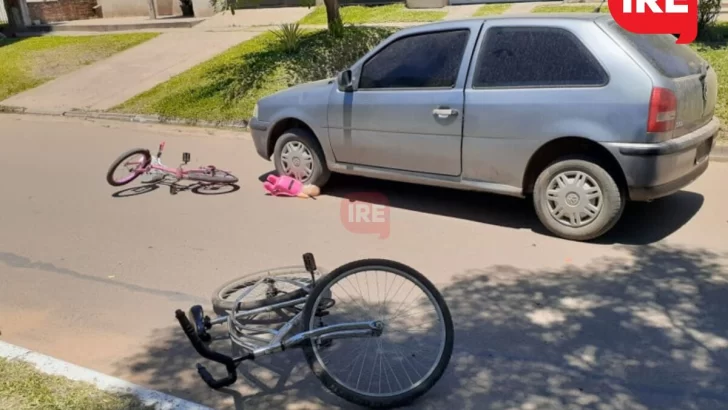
left=299, top=4, right=447, bottom=25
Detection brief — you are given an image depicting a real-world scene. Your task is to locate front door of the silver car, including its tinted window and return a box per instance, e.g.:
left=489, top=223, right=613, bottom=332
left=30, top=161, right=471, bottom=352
left=329, top=22, right=482, bottom=175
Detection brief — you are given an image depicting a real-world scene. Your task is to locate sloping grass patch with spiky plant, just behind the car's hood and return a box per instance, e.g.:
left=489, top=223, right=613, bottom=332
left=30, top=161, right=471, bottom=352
left=112, top=27, right=396, bottom=121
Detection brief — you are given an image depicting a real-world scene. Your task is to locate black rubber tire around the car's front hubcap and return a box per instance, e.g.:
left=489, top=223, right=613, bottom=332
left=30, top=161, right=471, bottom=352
left=273, top=128, right=331, bottom=188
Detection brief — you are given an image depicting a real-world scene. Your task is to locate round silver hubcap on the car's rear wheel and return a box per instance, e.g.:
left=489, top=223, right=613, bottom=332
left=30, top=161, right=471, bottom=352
left=546, top=171, right=603, bottom=228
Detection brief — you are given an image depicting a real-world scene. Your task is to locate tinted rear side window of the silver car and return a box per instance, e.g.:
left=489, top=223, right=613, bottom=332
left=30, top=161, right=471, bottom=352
left=473, top=27, right=608, bottom=88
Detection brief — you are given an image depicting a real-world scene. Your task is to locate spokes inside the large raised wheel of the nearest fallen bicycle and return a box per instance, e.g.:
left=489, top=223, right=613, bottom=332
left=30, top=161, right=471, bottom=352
left=315, top=268, right=445, bottom=396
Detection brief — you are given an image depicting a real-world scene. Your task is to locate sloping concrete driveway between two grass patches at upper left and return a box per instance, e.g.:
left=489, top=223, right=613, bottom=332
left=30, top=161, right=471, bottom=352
left=0, top=30, right=259, bottom=113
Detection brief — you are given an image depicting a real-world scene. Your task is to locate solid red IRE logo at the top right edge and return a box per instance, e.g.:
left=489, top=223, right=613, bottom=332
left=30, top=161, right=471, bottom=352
left=608, top=0, right=698, bottom=44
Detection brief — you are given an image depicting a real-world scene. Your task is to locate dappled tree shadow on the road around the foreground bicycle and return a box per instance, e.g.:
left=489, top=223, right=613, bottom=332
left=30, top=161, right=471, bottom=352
left=117, top=244, right=728, bottom=410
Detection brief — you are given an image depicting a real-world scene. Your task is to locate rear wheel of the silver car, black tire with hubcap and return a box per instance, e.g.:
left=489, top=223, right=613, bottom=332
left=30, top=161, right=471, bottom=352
left=533, top=158, right=626, bottom=241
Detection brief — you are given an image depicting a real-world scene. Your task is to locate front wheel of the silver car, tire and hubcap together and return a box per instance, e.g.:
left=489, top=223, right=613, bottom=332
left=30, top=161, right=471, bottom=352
left=273, top=128, right=331, bottom=187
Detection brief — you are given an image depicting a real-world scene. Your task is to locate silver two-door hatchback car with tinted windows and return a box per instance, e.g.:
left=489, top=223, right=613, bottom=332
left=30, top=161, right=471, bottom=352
left=249, top=14, right=719, bottom=240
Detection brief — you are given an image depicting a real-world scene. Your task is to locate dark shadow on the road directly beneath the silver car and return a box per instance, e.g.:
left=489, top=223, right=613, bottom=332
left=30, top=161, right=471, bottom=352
left=323, top=175, right=704, bottom=245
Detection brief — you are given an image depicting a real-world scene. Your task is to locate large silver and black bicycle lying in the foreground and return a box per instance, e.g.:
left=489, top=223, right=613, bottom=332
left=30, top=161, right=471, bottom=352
left=176, top=253, right=454, bottom=408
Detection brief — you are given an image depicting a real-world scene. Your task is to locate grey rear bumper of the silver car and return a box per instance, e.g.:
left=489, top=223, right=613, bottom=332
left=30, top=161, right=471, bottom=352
left=605, top=118, right=720, bottom=201
